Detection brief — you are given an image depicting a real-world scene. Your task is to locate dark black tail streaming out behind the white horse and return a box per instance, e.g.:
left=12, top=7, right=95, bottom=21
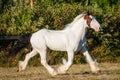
left=7, top=33, right=32, bottom=57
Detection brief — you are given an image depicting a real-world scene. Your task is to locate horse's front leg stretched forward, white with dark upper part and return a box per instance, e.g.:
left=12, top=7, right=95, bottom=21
left=82, top=47, right=100, bottom=73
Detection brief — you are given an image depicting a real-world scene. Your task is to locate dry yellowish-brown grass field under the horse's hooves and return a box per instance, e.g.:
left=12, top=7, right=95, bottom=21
left=0, top=63, right=120, bottom=80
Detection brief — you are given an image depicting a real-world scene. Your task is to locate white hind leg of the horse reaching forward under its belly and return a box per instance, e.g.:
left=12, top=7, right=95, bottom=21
left=37, top=49, right=57, bottom=76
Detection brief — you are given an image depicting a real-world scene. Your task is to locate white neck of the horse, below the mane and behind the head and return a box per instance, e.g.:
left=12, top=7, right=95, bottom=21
left=71, top=18, right=86, bottom=41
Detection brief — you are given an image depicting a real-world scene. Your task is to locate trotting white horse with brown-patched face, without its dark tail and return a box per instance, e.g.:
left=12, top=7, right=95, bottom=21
left=18, top=11, right=101, bottom=76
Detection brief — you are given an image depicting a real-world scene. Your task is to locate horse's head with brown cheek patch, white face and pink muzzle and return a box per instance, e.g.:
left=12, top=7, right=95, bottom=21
left=84, top=11, right=102, bottom=31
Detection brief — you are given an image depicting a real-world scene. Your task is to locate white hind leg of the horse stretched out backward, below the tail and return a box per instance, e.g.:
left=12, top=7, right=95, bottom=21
left=18, top=49, right=37, bottom=71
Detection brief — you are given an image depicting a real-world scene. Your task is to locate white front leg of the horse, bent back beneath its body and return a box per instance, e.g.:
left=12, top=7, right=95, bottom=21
left=57, top=51, right=74, bottom=74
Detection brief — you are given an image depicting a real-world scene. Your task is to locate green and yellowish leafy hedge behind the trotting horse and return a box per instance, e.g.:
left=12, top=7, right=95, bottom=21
left=0, top=0, right=120, bottom=66
